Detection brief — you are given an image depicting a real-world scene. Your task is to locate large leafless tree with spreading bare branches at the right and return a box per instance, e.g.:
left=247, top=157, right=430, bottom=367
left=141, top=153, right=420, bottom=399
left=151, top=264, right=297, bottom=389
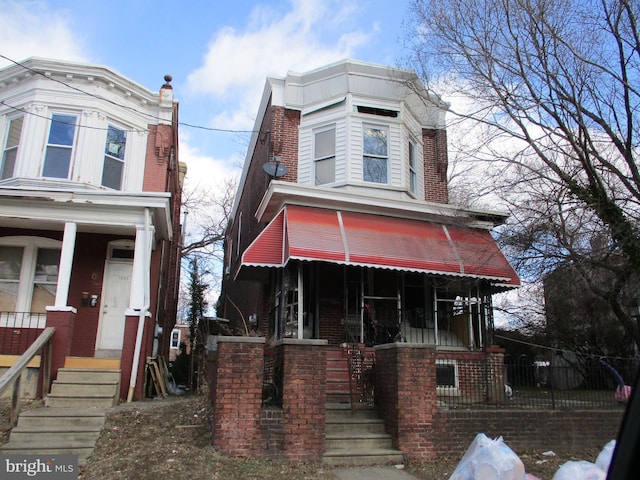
left=408, top=0, right=640, bottom=346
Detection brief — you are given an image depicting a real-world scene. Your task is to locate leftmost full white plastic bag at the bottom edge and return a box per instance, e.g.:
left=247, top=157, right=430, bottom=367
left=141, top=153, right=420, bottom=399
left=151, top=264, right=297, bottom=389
left=449, top=433, right=525, bottom=480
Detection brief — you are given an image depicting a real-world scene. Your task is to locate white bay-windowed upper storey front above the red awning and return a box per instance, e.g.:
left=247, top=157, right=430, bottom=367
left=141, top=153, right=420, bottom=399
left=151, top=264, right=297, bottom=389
left=268, top=60, right=448, bottom=203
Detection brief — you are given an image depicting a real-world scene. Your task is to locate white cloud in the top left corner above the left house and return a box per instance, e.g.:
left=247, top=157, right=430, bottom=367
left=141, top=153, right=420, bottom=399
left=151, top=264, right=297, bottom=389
left=0, top=0, right=87, bottom=67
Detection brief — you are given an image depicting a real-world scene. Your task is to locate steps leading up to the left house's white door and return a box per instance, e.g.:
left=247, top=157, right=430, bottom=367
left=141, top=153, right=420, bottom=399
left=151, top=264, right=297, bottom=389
left=2, top=368, right=120, bottom=465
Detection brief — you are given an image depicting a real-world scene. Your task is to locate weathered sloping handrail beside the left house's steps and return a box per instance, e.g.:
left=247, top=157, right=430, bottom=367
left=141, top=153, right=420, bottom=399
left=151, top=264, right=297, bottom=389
left=0, top=327, right=56, bottom=428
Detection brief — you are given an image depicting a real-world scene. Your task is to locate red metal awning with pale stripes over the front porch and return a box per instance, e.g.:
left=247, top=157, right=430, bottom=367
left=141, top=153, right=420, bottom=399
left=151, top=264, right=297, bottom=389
left=240, top=205, right=520, bottom=286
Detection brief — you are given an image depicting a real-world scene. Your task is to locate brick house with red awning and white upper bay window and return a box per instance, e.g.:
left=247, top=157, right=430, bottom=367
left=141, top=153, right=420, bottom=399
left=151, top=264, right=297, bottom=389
left=212, top=60, right=519, bottom=460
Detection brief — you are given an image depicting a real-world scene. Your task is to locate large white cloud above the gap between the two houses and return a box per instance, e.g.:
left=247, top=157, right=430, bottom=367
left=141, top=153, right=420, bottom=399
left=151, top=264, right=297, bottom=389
left=188, top=0, right=377, bottom=128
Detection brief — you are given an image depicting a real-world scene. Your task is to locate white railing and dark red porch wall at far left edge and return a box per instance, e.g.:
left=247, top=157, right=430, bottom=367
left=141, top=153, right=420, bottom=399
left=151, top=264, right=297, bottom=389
left=0, top=312, right=47, bottom=355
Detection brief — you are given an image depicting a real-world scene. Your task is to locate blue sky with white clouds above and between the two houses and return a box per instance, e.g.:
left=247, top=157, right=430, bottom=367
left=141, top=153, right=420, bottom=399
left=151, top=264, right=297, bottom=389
left=0, top=0, right=410, bottom=195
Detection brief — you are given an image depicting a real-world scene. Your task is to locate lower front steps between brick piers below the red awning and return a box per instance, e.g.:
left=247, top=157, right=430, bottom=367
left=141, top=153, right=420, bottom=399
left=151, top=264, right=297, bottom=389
left=322, top=404, right=403, bottom=465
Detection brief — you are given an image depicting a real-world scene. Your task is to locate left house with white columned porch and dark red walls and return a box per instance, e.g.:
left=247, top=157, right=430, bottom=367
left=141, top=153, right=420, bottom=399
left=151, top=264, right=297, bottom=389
left=0, top=58, right=186, bottom=398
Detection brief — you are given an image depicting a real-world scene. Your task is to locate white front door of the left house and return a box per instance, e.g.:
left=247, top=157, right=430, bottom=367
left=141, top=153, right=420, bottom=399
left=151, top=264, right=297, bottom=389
left=96, top=259, right=133, bottom=357
